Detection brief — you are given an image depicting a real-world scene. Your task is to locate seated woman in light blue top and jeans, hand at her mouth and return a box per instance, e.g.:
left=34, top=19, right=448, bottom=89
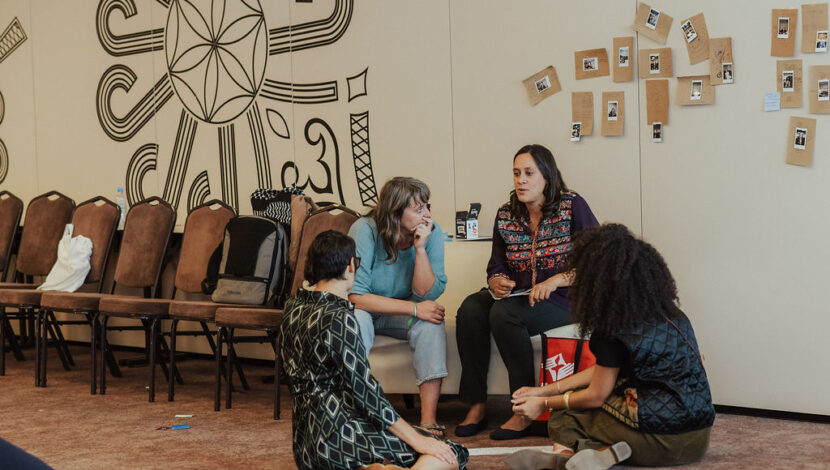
left=349, top=177, right=456, bottom=435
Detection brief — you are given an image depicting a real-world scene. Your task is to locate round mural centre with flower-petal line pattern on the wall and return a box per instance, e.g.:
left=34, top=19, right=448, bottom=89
left=165, top=0, right=268, bottom=124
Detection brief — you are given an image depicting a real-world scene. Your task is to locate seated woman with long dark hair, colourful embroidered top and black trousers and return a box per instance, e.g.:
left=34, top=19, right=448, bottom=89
left=455, top=145, right=597, bottom=440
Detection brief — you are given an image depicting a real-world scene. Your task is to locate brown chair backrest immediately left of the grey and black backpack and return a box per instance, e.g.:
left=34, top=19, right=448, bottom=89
left=175, top=200, right=236, bottom=293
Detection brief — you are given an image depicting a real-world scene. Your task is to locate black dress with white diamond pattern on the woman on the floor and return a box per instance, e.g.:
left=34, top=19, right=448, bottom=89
left=280, top=289, right=469, bottom=470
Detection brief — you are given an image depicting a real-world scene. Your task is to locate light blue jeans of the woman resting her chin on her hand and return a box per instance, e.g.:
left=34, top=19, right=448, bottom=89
left=354, top=308, right=447, bottom=386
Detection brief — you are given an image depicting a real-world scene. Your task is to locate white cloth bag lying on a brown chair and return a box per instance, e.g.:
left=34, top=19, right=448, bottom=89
left=38, top=224, right=92, bottom=292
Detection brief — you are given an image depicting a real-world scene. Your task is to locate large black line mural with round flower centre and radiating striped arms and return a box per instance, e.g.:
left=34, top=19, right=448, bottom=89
left=96, top=0, right=377, bottom=210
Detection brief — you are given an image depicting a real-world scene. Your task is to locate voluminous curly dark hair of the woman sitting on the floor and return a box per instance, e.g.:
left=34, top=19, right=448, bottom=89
left=568, top=224, right=680, bottom=337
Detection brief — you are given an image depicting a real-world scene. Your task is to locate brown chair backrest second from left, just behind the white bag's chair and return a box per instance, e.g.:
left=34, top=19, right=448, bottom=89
left=17, top=191, right=75, bottom=276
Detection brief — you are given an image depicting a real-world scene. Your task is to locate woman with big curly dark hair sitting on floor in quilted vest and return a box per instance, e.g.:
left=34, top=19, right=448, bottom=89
left=508, top=224, right=715, bottom=470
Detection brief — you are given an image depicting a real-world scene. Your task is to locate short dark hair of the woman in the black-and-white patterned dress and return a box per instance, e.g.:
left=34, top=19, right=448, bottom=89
left=304, top=230, right=355, bottom=284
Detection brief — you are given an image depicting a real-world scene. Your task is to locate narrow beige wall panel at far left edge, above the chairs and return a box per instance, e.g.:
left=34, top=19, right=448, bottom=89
left=0, top=0, right=39, bottom=204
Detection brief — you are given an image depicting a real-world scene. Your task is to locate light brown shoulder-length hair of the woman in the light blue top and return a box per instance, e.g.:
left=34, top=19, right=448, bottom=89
left=366, top=176, right=430, bottom=264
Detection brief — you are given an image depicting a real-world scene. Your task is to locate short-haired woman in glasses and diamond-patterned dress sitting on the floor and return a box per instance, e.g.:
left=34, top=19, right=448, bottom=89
left=280, top=230, right=469, bottom=470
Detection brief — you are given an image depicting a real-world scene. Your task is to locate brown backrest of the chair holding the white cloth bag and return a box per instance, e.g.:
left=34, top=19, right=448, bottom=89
left=72, top=196, right=121, bottom=292
